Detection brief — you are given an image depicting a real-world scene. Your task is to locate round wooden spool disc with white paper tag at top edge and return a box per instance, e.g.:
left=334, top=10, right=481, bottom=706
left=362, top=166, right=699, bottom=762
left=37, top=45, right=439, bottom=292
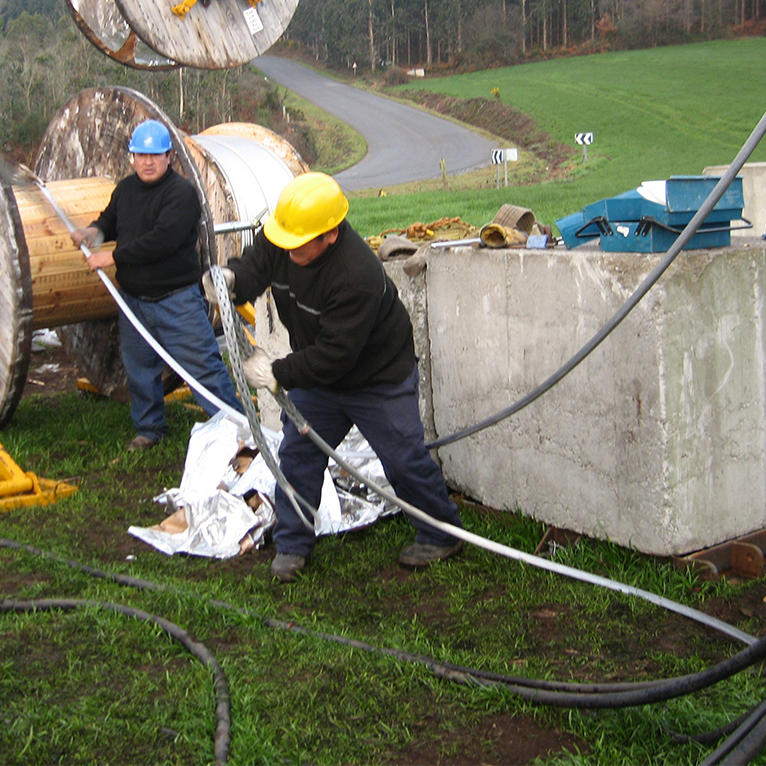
left=116, top=0, right=298, bottom=69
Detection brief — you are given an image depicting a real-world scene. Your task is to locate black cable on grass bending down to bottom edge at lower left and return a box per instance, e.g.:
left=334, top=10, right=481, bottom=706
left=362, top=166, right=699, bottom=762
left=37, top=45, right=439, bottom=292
left=0, top=600, right=231, bottom=766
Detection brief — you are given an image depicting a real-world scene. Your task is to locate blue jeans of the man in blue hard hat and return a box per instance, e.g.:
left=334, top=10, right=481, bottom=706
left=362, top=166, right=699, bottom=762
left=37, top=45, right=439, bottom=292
left=119, top=284, right=242, bottom=442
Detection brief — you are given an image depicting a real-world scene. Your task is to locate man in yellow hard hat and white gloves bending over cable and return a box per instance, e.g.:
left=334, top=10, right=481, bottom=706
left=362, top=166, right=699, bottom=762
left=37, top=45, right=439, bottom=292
left=203, top=173, right=462, bottom=582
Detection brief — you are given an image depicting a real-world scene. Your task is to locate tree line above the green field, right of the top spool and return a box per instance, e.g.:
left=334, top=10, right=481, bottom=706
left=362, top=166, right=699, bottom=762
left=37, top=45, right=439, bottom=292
left=285, top=0, right=766, bottom=70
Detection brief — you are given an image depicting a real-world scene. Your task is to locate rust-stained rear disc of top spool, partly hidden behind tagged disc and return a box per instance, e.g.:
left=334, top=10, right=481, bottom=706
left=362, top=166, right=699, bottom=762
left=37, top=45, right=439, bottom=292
left=66, top=0, right=179, bottom=71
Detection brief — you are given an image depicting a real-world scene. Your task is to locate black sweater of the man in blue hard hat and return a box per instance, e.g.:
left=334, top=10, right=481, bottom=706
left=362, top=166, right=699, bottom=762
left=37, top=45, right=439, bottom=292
left=91, top=168, right=201, bottom=298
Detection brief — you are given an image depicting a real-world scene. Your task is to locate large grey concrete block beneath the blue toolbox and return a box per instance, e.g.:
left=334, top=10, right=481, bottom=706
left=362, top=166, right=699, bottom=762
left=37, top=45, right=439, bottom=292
left=427, top=242, right=766, bottom=555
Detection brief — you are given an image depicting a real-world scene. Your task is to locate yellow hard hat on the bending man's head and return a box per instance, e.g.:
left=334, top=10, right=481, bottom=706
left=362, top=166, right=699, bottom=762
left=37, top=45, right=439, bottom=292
left=263, top=173, right=348, bottom=250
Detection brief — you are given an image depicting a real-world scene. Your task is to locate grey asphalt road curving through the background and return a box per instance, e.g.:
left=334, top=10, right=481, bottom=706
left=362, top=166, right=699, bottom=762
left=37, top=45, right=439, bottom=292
left=252, top=56, right=495, bottom=191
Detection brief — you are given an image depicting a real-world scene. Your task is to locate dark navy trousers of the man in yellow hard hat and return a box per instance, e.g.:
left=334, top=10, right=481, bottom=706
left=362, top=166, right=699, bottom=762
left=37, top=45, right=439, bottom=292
left=274, top=366, right=463, bottom=556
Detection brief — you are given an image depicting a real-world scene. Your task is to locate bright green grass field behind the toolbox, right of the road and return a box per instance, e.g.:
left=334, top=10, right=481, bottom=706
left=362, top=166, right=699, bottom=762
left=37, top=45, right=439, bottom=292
left=350, top=37, right=766, bottom=236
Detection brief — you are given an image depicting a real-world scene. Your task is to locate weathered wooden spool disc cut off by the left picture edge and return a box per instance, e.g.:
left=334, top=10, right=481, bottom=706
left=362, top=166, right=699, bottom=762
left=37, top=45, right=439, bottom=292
left=0, top=181, right=32, bottom=428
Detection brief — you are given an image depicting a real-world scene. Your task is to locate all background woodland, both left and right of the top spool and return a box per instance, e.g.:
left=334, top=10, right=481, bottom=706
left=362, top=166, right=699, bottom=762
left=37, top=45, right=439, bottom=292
left=0, top=0, right=766, bottom=164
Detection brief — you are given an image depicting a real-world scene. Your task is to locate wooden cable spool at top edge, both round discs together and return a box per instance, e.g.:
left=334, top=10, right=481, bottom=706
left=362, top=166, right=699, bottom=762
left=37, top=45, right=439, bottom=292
left=67, top=0, right=298, bottom=69
